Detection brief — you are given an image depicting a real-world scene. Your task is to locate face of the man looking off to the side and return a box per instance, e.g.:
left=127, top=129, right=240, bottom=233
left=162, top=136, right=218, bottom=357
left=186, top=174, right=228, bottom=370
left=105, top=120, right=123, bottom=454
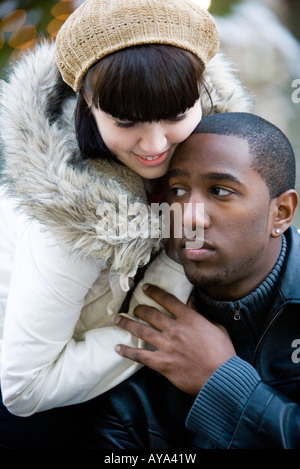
left=169, top=134, right=280, bottom=300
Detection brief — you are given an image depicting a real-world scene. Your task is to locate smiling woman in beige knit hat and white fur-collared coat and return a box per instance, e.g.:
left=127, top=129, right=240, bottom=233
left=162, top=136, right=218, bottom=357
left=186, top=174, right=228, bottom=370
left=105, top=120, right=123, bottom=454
left=0, top=0, right=250, bottom=447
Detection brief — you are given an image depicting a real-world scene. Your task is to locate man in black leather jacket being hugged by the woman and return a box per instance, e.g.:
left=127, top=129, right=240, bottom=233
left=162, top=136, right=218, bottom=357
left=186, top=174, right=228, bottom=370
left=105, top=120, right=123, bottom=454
left=95, top=113, right=300, bottom=449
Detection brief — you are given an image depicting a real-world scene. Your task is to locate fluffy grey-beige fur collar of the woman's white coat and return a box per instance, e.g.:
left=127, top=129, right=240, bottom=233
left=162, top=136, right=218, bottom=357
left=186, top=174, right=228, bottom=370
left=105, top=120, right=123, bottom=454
left=0, top=41, right=251, bottom=283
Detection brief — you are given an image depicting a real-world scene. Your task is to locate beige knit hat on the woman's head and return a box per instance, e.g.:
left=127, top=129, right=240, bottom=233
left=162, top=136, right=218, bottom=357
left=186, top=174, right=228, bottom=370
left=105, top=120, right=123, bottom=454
left=56, top=0, right=219, bottom=91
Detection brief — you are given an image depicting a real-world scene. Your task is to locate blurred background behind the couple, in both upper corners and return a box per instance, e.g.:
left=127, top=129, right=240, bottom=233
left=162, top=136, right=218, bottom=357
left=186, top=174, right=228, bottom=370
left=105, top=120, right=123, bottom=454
left=0, top=0, right=300, bottom=224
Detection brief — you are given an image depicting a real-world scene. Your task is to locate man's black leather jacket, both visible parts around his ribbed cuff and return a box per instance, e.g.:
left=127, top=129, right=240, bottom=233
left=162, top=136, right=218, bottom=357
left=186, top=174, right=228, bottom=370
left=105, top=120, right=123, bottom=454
left=88, top=228, right=300, bottom=449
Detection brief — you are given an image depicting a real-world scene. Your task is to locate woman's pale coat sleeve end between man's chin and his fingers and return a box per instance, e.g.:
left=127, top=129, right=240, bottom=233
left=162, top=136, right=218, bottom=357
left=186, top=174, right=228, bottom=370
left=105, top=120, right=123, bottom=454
left=128, top=251, right=193, bottom=315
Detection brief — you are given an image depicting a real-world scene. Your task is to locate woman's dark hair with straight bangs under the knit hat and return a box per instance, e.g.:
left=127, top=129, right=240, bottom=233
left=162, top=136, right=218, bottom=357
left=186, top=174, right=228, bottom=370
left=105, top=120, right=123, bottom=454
left=75, top=44, right=204, bottom=158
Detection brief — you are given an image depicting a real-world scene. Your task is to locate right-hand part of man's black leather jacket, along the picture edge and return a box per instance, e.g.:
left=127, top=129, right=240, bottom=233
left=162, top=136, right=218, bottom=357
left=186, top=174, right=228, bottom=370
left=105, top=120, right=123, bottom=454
left=227, top=227, right=300, bottom=449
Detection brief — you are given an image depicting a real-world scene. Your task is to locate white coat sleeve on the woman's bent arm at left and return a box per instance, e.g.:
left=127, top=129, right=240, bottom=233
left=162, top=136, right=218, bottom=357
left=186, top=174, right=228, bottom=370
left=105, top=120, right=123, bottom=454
left=1, top=222, right=140, bottom=416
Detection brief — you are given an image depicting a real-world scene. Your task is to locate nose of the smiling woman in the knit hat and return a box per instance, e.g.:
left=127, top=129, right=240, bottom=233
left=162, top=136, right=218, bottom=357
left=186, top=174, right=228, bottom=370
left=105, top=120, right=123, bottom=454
left=139, top=122, right=168, bottom=156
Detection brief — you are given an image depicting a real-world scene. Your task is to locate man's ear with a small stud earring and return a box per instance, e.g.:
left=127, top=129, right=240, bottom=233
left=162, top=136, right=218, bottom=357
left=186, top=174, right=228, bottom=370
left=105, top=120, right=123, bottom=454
left=271, top=189, right=298, bottom=238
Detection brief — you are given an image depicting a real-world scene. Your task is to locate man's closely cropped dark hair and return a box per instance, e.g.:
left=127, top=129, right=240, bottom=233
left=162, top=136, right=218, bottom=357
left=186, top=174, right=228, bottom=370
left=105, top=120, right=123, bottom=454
left=194, top=112, right=296, bottom=199
